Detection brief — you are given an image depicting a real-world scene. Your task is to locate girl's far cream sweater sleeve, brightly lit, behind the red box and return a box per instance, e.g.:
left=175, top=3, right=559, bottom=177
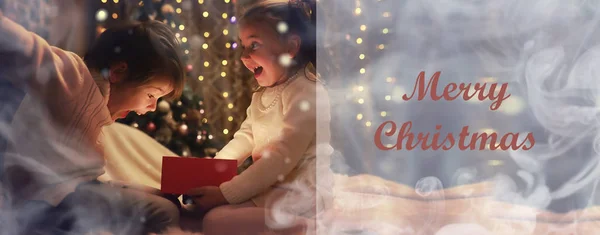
left=215, top=106, right=254, bottom=165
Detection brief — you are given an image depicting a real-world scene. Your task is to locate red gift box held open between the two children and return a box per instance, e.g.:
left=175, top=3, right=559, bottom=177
left=160, top=157, right=237, bottom=194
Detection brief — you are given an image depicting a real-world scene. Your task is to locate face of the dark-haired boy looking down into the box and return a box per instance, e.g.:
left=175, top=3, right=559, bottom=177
left=108, top=76, right=173, bottom=120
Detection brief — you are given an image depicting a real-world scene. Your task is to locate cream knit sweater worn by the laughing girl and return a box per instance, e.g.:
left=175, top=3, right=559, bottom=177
left=216, top=70, right=331, bottom=207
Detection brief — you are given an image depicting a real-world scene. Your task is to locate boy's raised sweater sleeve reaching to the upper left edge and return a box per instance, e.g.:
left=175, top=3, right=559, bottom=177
left=0, top=15, right=112, bottom=158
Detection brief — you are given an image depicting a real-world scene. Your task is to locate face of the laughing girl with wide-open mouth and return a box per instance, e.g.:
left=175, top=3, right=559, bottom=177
left=240, top=23, right=294, bottom=86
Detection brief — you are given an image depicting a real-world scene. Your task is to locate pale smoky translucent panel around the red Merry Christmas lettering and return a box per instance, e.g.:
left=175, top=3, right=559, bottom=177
left=318, top=0, right=600, bottom=234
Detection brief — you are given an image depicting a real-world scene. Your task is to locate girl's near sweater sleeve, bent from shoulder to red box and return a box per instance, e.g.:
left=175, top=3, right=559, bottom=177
left=220, top=80, right=317, bottom=204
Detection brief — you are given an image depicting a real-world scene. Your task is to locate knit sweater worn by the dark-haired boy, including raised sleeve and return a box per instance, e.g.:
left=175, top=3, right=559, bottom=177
left=0, top=13, right=113, bottom=205
